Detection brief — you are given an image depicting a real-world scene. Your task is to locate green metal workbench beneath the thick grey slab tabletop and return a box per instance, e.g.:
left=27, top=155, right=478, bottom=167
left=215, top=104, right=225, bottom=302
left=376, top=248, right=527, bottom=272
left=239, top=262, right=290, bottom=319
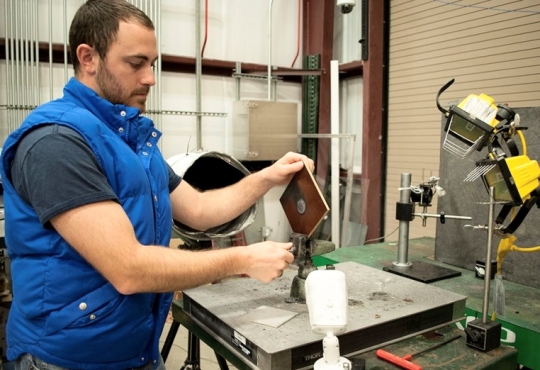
left=164, top=238, right=524, bottom=370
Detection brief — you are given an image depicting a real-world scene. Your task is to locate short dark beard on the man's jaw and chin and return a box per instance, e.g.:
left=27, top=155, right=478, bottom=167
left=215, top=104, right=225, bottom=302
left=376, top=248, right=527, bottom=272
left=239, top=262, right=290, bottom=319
left=96, top=62, right=150, bottom=113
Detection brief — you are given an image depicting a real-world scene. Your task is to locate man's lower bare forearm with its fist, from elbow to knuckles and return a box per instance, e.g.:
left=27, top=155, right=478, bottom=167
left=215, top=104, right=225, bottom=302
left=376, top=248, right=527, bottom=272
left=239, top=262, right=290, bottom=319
left=114, top=241, right=294, bottom=294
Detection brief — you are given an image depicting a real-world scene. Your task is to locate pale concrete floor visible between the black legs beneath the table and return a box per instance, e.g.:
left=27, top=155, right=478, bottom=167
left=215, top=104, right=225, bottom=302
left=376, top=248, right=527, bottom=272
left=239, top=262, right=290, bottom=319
left=160, top=322, right=236, bottom=370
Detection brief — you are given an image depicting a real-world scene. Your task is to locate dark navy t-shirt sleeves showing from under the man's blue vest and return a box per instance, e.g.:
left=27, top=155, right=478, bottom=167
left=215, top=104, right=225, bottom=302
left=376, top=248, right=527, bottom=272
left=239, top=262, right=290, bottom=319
left=11, top=124, right=181, bottom=227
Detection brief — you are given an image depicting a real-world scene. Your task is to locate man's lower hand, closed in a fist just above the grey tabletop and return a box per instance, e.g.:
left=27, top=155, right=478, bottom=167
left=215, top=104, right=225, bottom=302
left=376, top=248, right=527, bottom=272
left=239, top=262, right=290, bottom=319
left=243, top=241, right=294, bottom=283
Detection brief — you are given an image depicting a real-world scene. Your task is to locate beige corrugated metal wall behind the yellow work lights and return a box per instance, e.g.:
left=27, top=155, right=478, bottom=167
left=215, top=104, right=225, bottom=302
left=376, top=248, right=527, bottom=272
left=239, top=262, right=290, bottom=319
left=385, top=0, right=540, bottom=240
